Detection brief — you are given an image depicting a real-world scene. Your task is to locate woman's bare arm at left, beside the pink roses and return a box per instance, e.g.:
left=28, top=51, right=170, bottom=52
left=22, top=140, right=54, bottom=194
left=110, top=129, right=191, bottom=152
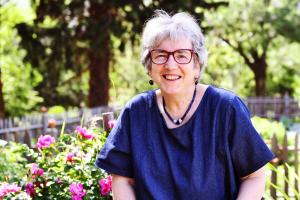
left=112, top=174, right=135, bottom=200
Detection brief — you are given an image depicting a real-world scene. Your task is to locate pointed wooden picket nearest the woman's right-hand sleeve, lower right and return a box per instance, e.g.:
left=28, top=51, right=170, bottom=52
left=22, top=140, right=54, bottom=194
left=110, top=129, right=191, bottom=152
left=270, top=134, right=279, bottom=199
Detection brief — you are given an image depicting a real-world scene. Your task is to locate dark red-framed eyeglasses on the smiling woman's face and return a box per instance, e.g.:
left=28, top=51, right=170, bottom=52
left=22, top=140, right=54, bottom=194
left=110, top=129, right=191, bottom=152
left=150, top=49, right=194, bottom=65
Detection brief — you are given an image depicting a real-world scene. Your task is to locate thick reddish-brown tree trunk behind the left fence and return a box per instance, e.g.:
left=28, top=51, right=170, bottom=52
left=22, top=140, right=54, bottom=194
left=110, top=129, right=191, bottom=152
left=89, top=30, right=110, bottom=107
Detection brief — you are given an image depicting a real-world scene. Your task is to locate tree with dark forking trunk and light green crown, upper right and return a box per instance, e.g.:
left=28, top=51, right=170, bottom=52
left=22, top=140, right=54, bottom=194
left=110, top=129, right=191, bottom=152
left=205, top=0, right=299, bottom=96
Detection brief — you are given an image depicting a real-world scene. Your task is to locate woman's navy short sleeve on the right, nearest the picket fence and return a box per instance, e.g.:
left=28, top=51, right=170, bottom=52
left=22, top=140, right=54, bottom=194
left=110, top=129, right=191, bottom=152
left=228, top=97, right=274, bottom=177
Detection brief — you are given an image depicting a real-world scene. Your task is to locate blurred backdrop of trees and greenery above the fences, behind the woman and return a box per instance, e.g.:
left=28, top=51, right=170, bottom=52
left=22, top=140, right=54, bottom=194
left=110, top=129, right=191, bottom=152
left=0, top=0, right=300, bottom=118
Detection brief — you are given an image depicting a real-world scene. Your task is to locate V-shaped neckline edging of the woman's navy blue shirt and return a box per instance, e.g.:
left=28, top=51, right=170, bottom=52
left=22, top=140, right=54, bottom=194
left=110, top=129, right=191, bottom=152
left=152, top=85, right=212, bottom=130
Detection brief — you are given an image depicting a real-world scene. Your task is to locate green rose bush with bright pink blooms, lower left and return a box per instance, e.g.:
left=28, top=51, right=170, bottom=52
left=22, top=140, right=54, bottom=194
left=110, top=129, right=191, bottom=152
left=1, top=119, right=111, bottom=200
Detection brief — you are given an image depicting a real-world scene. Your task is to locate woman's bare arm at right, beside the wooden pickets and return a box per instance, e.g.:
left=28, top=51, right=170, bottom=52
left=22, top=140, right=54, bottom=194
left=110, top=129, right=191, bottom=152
left=237, top=166, right=266, bottom=200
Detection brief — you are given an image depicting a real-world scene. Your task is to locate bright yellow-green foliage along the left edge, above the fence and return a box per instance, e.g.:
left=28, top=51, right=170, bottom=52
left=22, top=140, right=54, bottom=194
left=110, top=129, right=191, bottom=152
left=0, top=1, right=43, bottom=116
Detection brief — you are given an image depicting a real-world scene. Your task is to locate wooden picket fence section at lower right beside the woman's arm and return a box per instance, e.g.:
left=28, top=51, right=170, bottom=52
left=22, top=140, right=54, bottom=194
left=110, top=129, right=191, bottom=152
left=270, top=132, right=300, bottom=200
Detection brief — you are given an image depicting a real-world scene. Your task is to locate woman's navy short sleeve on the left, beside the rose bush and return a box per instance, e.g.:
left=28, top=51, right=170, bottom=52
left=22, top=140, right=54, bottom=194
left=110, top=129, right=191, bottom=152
left=95, top=108, right=133, bottom=177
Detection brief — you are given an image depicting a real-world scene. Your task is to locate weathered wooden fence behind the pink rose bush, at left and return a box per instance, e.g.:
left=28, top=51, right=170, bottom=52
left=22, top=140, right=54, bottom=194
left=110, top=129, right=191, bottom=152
left=0, top=106, right=120, bottom=148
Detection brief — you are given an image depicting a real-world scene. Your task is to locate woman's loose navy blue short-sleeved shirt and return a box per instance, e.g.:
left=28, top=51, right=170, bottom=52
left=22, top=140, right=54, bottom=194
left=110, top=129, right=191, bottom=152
left=96, top=86, right=273, bottom=200
